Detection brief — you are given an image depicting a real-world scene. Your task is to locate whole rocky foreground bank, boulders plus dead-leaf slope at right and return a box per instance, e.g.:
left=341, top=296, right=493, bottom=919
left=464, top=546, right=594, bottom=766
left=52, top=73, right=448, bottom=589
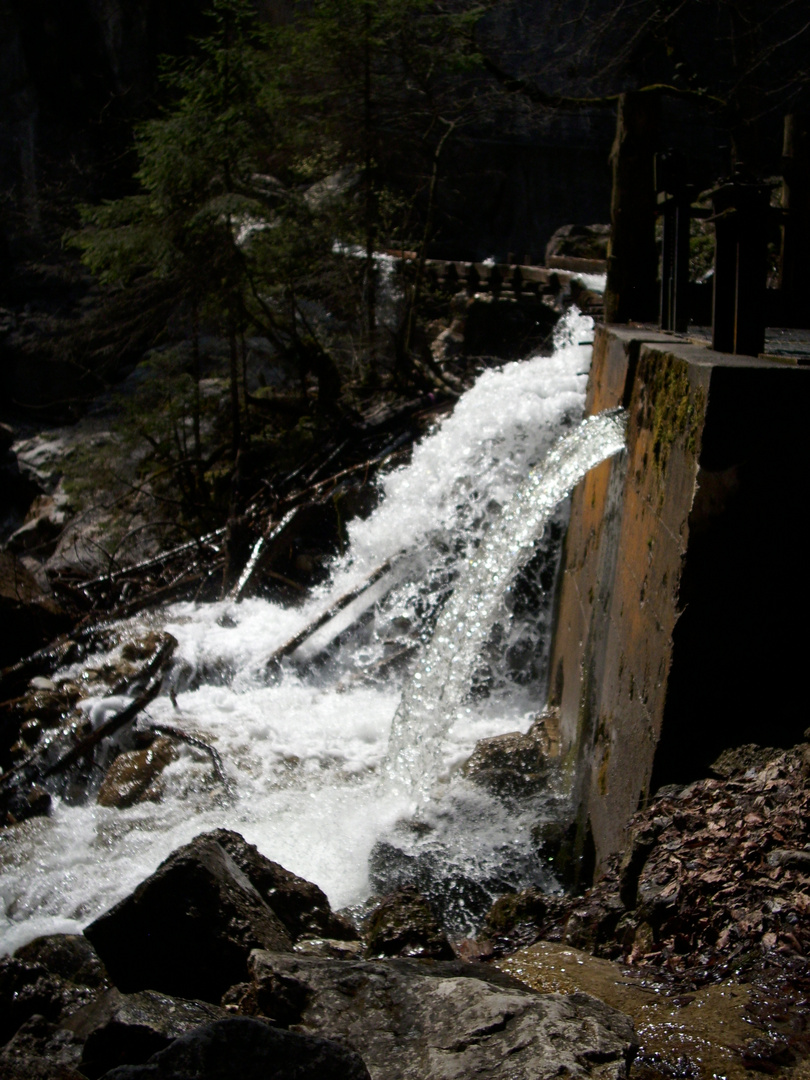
left=0, top=699, right=810, bottom=1080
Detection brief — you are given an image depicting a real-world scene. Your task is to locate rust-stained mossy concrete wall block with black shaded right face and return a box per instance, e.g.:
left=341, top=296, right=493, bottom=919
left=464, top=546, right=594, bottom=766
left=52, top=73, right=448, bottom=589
left=550, top=327, right=810, bottom=873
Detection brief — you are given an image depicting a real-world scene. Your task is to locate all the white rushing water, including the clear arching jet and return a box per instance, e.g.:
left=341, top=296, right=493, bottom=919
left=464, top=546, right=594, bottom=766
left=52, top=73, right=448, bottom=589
left=0, top=311, right=623, bottom=953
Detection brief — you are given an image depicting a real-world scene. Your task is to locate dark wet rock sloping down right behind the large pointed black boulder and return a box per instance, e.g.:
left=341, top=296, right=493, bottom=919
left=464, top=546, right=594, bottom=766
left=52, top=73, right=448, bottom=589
left=208, top=828, right=359, bottom=941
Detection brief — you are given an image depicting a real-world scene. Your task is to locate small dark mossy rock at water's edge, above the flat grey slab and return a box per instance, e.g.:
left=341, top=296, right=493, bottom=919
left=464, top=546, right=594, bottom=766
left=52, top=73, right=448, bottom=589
left=366, top=886, right=455, bottom=960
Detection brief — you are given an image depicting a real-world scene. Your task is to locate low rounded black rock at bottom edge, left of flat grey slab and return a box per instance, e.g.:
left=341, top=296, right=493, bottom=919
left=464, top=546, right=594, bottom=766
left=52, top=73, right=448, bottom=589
left=96, top=1016, right=369, bottom=1080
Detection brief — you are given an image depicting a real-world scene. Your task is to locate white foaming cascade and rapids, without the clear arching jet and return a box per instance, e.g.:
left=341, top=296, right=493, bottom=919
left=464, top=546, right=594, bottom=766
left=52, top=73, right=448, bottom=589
left=0, top=313, right=604, bottom=951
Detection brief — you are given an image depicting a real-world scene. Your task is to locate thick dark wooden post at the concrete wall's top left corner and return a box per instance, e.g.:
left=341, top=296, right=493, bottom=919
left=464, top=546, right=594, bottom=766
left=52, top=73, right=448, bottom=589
left=605, top=92, right=661, bottom=323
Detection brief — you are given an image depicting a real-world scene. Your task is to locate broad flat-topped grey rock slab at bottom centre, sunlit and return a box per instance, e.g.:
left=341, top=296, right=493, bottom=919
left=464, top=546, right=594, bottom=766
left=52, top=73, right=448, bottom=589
left=244, top=951, right=635, bottom=1080
